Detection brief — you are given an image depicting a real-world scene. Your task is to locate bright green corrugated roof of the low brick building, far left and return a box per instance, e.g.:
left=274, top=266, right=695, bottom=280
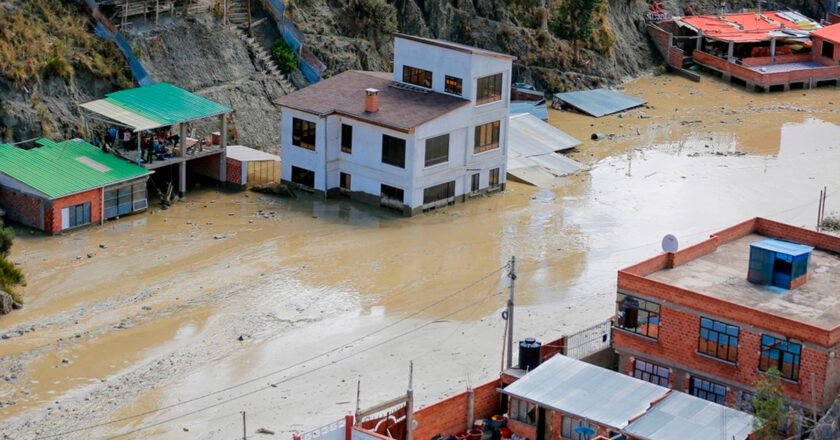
left=0, top=139, right=151, bottom=198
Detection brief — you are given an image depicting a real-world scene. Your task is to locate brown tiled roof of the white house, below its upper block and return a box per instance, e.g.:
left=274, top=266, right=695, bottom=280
left=275, top=70, right=470, bottom=132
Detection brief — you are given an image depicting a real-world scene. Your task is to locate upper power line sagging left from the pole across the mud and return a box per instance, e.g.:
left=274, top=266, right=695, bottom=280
left=41, top=264, right=508, bottom=438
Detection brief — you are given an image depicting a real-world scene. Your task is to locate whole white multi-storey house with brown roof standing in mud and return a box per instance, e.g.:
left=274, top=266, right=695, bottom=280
left=277, top=34, right=515, bottom=215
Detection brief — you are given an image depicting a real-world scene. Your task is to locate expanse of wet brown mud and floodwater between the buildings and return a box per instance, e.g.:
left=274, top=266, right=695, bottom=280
left=0, top=76, right=840, bottom=439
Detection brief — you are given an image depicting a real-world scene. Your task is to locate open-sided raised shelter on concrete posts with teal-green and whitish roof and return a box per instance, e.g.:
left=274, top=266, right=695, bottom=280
left=79, top=83, right=233, bottom=193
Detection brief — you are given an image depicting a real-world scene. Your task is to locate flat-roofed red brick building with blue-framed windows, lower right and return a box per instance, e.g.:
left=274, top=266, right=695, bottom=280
left=613, top=218, right=840, bottom=412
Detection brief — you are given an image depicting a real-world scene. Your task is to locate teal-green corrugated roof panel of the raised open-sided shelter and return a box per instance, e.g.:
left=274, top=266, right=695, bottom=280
left=105, top=83, right=233, bottom=125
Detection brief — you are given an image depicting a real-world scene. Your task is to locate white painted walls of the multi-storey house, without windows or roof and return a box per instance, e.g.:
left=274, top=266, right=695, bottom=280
left=281, top=37, right=512, bottom=209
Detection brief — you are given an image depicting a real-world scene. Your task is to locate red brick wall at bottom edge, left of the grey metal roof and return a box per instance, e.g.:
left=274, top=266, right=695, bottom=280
left=413, top=379, right=502, bottom=440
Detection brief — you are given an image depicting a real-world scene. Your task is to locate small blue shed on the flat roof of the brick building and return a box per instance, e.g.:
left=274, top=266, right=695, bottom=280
left=747, top=238, right=814, bottom=289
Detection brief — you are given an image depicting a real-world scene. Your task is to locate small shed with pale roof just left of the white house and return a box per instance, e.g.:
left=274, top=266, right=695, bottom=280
left=227, top=145, right=280, bottom=188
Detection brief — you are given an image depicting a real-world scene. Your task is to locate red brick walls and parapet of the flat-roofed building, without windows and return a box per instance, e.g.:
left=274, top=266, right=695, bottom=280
left=613, top=218, right=840, bottom=408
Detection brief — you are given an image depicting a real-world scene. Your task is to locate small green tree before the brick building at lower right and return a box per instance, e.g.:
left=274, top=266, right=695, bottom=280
left=752, top=368, right=788, bottom=440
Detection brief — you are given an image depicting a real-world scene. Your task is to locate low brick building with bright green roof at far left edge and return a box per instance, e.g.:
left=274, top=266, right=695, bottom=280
left=0, top=139, right=153, bottom=234
